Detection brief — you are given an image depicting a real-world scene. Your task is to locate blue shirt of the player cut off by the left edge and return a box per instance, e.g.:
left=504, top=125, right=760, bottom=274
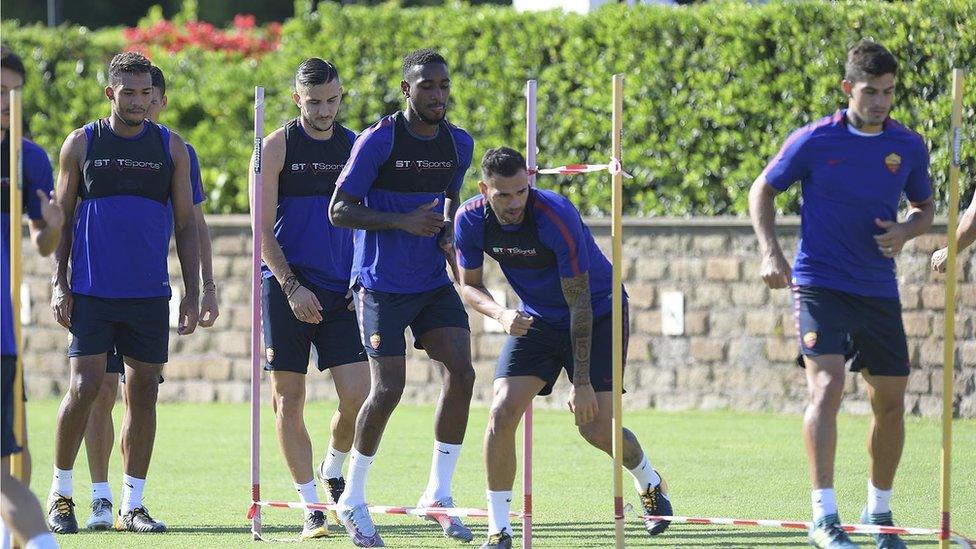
left=0, top=136, right=54, bottom=356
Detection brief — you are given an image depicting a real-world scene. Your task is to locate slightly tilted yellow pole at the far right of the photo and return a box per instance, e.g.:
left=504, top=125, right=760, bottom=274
left=939, top=69, right=965, bottom=549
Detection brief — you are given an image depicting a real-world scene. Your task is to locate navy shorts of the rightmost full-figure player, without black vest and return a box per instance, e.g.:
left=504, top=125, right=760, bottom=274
left=793, top=286, right=911, bottom=376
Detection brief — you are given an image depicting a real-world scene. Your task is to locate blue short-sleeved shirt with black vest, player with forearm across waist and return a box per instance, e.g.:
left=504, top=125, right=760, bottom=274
left=336, top=113, right=474, bottom=293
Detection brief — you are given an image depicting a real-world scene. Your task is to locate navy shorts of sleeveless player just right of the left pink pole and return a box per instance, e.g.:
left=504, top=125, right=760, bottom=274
left=261, top=275, right=366, bottom=374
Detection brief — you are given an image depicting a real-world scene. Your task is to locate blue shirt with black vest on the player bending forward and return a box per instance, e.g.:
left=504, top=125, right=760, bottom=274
left=454, top=188, right=613, bottom=329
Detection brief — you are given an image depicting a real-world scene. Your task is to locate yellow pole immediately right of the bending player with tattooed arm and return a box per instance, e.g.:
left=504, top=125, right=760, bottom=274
left=610, top=74, right=624, bottom=548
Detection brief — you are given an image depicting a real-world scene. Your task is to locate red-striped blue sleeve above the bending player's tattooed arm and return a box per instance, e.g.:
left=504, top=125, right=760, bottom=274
left=535, top=197, right=590, bottom=278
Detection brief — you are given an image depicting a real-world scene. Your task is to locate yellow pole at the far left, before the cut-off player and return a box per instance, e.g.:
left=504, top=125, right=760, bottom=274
left=7, top=89, right=26, bottom=482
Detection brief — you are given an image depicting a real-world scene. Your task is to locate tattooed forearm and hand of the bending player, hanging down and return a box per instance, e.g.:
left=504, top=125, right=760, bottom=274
left=560, top=273, right=598, bottom=425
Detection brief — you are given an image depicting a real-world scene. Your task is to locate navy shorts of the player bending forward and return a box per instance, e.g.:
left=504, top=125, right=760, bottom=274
left=495, top=303, right=630, bottom=395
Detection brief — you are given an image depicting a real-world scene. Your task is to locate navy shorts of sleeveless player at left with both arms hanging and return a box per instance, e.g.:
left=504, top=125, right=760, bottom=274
left=68, top=294, right=169, bottom=364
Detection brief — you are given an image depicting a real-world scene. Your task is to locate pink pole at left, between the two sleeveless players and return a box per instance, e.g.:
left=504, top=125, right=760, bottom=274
left=251, top=86, right=264, bottom=540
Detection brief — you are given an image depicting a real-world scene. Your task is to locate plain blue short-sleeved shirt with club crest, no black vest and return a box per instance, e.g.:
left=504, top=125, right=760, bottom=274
left=763, top=109, right=932, bottom=298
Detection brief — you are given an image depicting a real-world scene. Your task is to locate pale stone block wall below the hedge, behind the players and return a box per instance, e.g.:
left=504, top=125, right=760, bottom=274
left=17, top=216, right=976, bottom=417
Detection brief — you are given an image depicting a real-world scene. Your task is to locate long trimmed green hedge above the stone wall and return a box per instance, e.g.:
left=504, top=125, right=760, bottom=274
left=2, top=0, right=976, bottom=215
